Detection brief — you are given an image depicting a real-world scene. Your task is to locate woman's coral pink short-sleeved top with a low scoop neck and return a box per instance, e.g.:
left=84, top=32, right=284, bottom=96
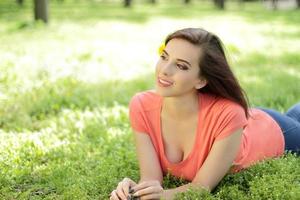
left=129, top=91, right=285, bottom=181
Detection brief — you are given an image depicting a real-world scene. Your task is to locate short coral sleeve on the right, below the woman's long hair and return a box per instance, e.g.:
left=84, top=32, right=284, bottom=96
left=215, top=103, right=248, bottom=140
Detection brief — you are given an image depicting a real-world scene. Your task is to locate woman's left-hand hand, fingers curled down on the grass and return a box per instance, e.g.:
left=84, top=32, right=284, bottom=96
left=109, top=178, right=137, bottom=200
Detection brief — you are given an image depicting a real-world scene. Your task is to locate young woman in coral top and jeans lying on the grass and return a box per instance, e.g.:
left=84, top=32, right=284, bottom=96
left=110, top=28, right=300, bottom=200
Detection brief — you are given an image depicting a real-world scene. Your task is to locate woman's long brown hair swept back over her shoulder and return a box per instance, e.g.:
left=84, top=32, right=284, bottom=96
left=165, top=28, right=249, bottom=117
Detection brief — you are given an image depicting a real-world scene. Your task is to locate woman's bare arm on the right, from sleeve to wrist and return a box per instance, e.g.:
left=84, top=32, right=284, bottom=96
left=164, top=128, right=242, bottom=200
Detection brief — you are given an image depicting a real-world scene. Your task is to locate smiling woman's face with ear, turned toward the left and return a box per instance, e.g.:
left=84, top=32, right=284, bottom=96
left=155, top=38, right=206, bottom=97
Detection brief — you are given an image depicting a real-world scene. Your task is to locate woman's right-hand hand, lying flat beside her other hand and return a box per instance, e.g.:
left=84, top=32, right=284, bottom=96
left=132, top=181, right=164, bottom=200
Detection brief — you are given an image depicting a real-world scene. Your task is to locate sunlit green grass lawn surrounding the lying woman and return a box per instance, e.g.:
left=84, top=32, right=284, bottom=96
left=0, top=0, right=300, bottom=200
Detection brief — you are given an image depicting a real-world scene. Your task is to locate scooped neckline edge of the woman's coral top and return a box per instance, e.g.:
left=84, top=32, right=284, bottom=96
left=158, top=93, right=203, bottom=166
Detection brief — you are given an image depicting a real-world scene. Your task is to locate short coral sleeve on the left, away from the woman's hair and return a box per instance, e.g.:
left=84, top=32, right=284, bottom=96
left=129, top=94, right=148, bottom=133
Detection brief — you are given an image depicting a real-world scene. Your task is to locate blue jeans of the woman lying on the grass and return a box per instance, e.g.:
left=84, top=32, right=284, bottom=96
left=258, top=103, right=300, bottom=155
